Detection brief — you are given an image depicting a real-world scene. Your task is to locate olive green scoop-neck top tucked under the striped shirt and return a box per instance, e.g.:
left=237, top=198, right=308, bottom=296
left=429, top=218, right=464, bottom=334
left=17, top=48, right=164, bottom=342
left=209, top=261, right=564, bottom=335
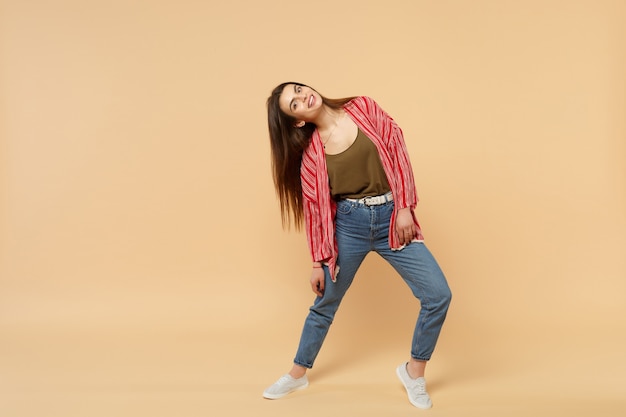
left=326, top=129, right=391, bottom=200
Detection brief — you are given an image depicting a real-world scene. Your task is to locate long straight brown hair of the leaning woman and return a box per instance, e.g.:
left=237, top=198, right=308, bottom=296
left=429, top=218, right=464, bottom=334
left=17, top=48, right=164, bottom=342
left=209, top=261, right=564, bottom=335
left=267, top=82, right=354, bottom=230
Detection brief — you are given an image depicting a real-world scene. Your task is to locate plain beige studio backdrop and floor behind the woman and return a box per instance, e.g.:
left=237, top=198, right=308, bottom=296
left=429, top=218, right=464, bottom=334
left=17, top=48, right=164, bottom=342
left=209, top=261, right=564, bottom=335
left=0, top=0, right=626, bottom=417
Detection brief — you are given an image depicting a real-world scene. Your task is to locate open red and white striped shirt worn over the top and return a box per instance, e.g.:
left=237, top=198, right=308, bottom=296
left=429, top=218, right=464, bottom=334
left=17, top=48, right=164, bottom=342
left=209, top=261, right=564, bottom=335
left=300, top=97, right=423, bottom=281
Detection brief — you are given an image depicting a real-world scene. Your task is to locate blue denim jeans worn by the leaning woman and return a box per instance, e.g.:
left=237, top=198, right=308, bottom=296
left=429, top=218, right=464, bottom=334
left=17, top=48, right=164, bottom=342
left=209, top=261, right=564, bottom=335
left=294, top=200, right=452, bottom=368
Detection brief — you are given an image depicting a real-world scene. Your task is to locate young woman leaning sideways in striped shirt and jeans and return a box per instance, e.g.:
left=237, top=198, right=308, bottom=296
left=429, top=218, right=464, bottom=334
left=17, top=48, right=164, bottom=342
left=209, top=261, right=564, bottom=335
left=263, top=82, right=451, bottom=408
